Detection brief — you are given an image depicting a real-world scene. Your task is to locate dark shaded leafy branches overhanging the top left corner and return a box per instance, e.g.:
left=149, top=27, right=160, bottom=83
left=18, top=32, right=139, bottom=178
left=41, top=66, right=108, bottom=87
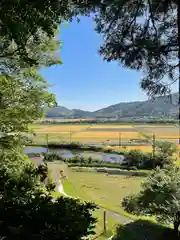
left=0, top=0, right=99, bottom=66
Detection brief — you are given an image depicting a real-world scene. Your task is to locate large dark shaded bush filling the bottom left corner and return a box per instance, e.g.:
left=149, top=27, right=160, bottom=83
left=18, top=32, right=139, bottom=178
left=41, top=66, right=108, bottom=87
left=0, top=150, right=96, bottom=240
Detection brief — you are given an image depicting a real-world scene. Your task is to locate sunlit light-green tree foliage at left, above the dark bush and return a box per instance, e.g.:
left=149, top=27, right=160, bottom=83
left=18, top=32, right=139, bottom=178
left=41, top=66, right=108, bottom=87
left=0, top=30, right=60, bottom=147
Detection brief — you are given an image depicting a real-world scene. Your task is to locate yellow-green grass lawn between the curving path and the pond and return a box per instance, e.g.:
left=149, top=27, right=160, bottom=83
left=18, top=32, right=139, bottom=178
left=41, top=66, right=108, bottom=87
left=63, top=170, right=144, bottom=217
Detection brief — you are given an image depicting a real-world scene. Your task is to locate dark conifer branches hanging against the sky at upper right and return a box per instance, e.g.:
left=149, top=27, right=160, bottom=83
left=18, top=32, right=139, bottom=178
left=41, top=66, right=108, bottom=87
left=95, top=0, right=180, bottom=96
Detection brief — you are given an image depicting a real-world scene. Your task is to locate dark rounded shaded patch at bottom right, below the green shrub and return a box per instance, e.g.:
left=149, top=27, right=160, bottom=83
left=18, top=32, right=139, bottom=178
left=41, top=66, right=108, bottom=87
left=113, top=220, right=180, bottom=240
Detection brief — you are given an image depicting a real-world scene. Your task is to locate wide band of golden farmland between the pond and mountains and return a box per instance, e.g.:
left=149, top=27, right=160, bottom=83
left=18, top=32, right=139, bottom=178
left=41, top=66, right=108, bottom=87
left=31, top=123, right=179, bottom=145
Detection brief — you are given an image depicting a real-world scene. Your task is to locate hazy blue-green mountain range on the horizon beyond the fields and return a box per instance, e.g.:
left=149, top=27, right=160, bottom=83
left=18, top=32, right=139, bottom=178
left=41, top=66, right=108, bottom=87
left=46, top=93, right=178, bottom=118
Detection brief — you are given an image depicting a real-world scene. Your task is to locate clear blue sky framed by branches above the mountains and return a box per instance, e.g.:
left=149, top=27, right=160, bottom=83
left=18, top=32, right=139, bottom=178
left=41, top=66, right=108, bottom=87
left=41, top=17, right=176, bottom=111
